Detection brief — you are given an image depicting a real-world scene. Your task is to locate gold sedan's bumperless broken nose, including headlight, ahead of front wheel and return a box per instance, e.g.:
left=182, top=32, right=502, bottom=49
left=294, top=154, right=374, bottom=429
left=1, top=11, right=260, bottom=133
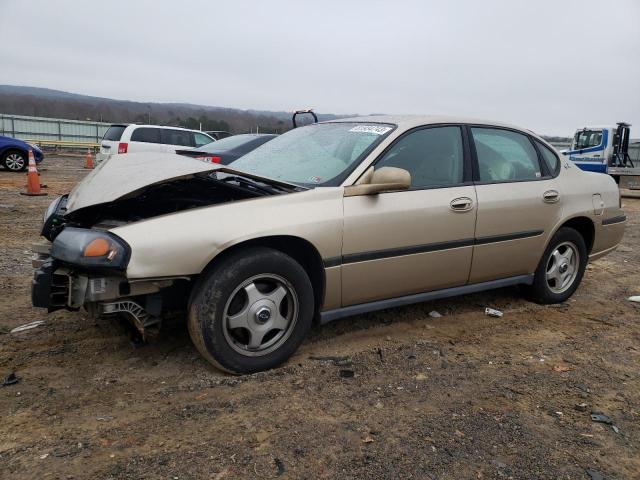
left=31, top=221, right=191, bottom=338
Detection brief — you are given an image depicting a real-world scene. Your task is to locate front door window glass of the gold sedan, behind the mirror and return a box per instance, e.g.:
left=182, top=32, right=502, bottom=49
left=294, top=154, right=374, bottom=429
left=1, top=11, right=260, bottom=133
left=376, top=127, right=464, bottom=188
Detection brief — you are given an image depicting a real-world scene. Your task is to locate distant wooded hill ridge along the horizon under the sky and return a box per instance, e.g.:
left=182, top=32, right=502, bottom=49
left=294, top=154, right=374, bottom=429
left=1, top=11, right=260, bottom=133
left=0, top=85, right=345, bottom=133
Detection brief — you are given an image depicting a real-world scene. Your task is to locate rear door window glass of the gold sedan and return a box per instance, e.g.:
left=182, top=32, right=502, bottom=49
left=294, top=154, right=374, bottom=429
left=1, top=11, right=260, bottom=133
left=471, top=128, right=542, bottom=182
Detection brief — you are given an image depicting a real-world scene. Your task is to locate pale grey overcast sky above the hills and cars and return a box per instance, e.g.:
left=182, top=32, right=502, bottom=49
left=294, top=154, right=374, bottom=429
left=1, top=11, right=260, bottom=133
left=0, top=0, right=640, bottom=137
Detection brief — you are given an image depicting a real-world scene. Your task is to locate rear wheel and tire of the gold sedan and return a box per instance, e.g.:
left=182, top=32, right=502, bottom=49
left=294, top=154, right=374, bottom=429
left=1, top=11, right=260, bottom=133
left=528, top=227, right=588, bottom=304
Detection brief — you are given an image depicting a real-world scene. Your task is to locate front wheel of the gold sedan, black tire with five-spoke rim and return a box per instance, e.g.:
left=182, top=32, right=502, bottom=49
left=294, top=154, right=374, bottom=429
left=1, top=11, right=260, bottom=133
left=188, top=247, right=314, bottom=374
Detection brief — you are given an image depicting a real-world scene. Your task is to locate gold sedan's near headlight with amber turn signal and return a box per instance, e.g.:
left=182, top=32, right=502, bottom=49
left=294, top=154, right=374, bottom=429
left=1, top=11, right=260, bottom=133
left=51, top=227, right=131, bottom=270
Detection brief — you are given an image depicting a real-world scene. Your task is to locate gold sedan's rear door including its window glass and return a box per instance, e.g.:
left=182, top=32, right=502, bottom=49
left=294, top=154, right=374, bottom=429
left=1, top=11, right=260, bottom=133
left=469, top=126, right=563, bottom=283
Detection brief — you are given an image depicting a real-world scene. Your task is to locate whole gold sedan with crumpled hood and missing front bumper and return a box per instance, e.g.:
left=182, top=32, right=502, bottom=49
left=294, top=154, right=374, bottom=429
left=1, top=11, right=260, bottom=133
left=32, top=116, right=626, bottom=373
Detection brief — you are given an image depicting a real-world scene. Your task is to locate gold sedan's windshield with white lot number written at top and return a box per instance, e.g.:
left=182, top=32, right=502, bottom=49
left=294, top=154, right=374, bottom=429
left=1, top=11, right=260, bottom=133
left=231, top=122, right=395, bottom=187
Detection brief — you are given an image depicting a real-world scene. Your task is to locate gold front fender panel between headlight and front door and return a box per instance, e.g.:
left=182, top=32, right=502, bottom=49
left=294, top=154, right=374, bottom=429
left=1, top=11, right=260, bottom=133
left=111, top=187, right=343, bottom=279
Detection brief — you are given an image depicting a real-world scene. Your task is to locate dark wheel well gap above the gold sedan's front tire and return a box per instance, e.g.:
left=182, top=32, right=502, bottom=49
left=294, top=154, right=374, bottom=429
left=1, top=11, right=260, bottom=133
left=205, top=235, right=325, bottom=314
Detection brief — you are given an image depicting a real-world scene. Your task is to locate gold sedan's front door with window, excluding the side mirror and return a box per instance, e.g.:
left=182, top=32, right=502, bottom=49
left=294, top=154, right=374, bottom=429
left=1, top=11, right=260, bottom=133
left=342, top=126, right=477, bottom=306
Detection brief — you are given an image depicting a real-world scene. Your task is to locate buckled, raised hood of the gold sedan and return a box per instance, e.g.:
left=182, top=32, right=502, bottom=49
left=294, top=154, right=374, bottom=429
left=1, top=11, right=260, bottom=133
left=66, top=152, right=291, bottom=213
